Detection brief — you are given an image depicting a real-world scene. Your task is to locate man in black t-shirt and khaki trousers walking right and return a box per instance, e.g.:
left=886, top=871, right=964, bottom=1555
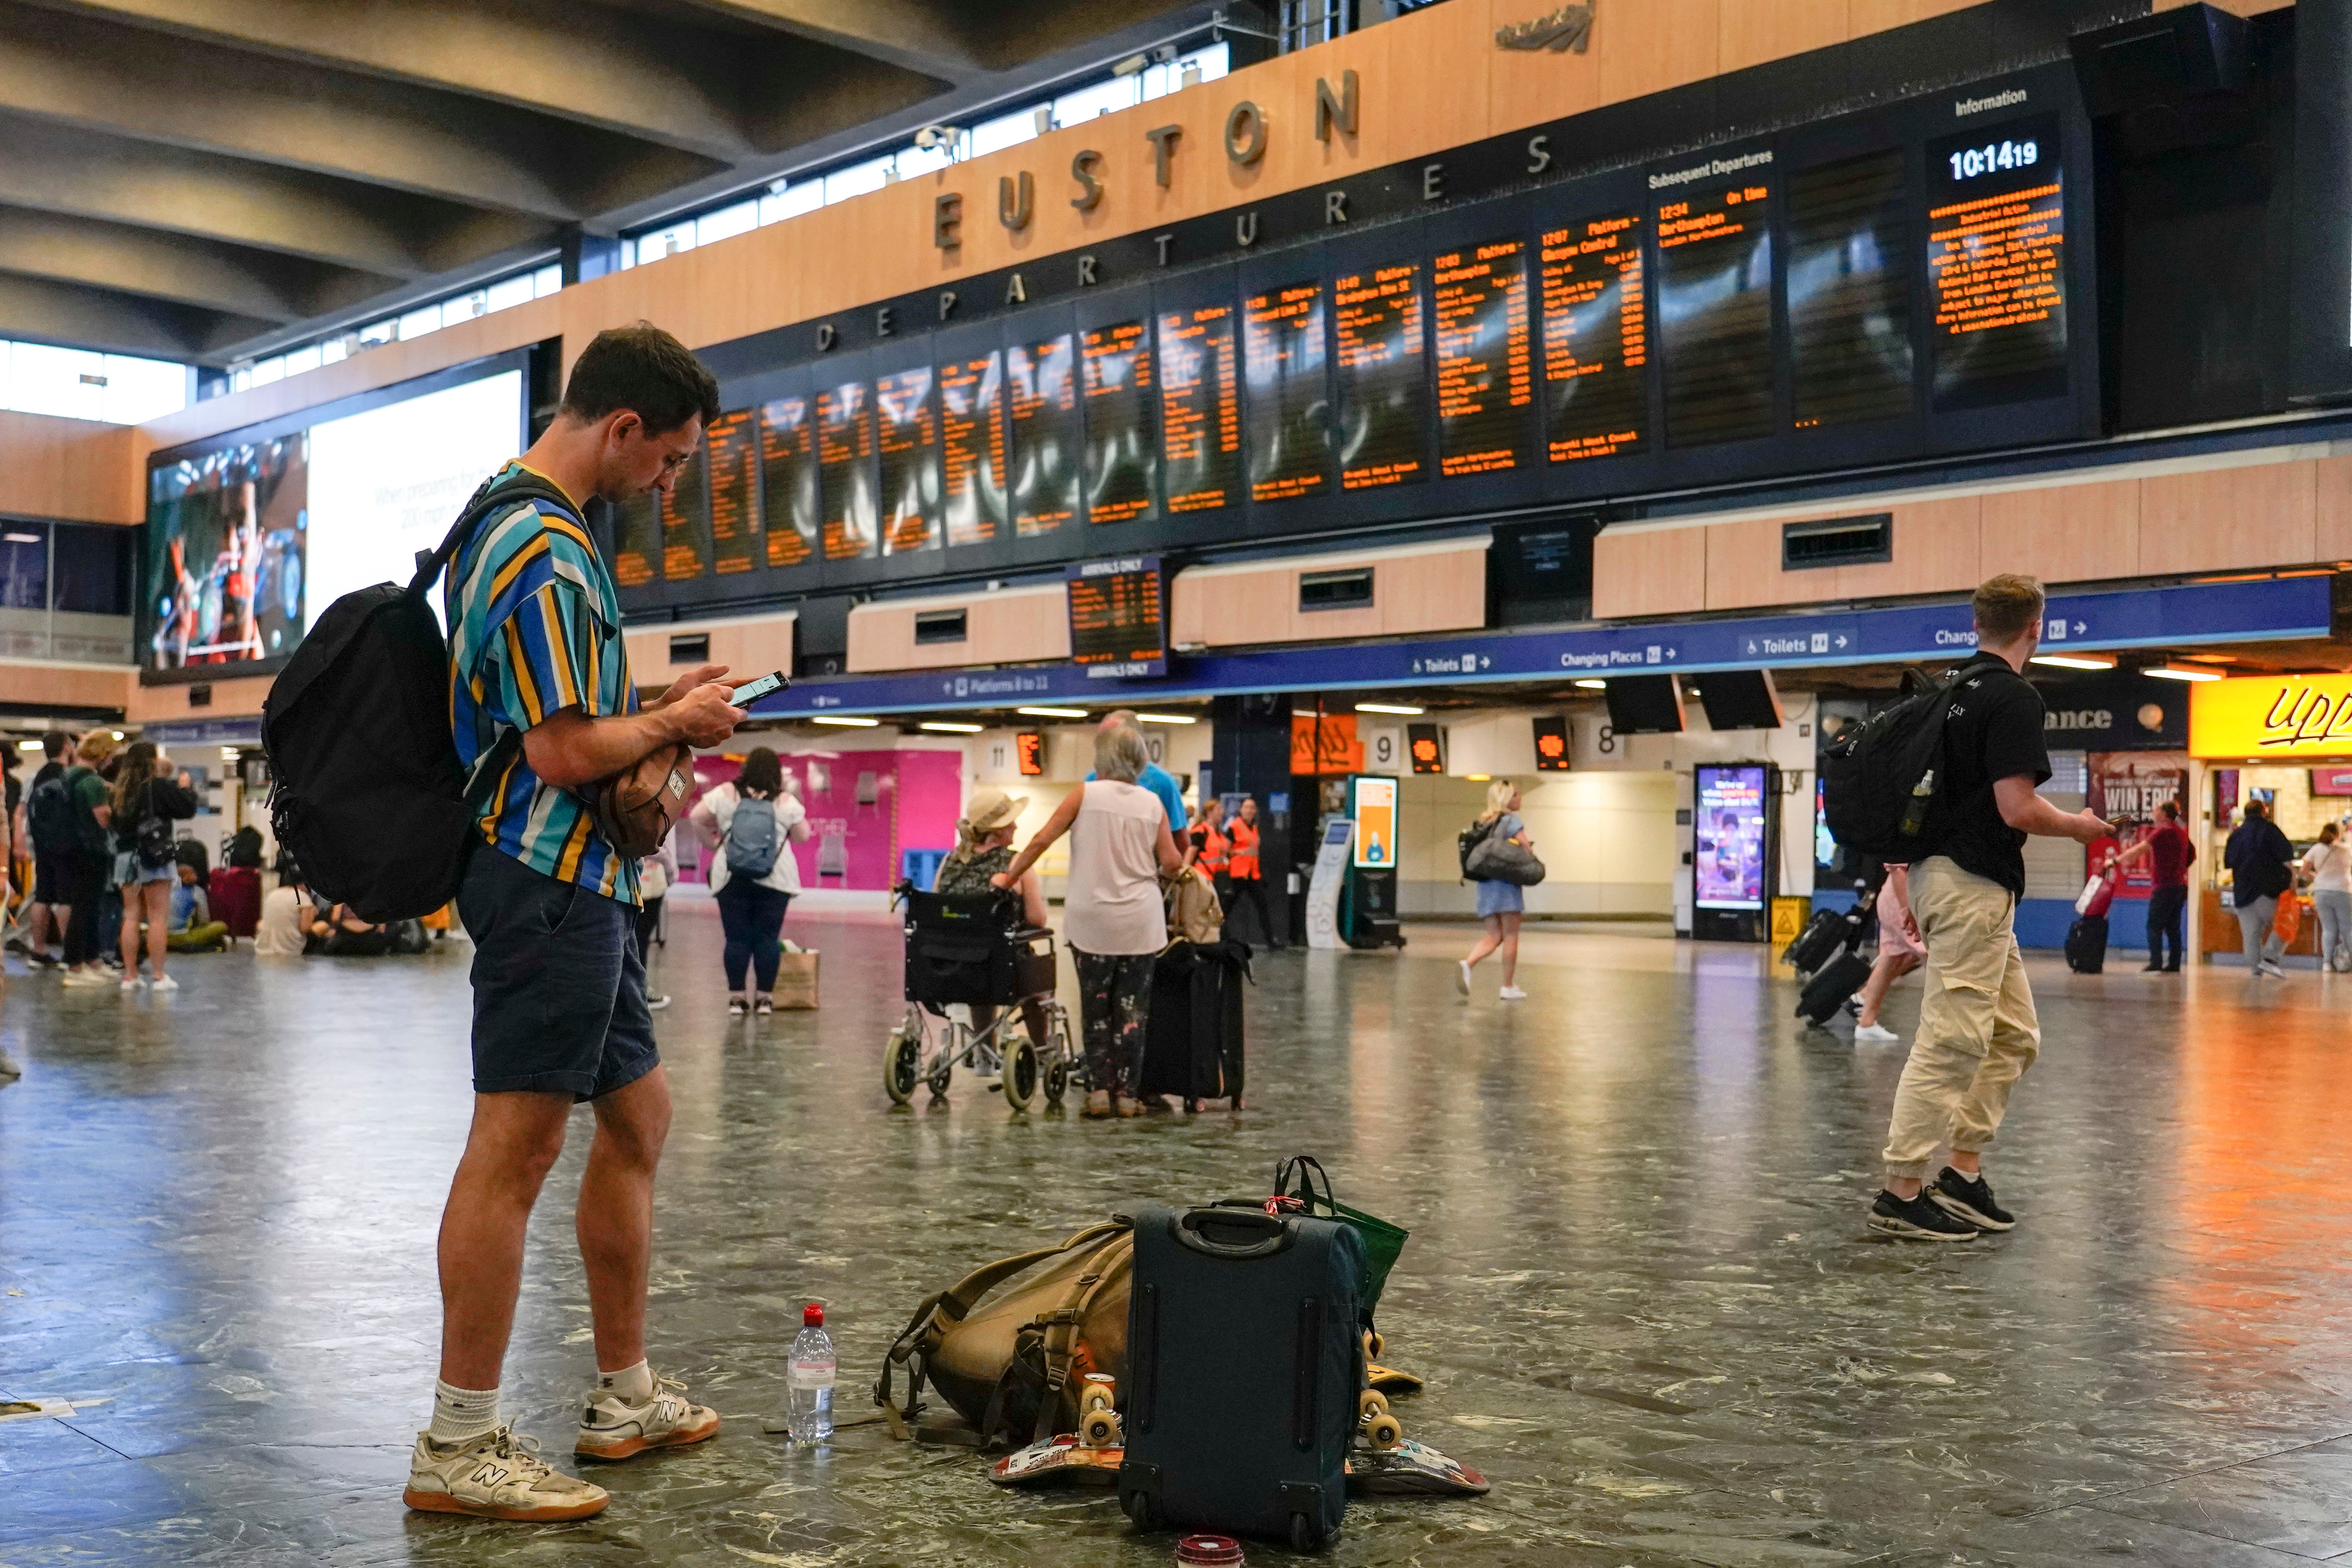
left=1870, top=573, right=2112, bottom=1241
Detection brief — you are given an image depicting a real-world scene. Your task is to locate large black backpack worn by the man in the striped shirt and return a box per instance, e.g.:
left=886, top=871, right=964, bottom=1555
left=261, top=472, right=574, bottom=924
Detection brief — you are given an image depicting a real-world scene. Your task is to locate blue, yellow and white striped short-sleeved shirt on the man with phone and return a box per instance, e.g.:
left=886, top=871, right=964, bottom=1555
left=442, top=463, right=637, bottom=903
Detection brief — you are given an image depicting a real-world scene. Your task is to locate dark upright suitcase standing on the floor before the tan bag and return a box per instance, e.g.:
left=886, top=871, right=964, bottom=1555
left=1120, top=1209, right=1364, bottom=1552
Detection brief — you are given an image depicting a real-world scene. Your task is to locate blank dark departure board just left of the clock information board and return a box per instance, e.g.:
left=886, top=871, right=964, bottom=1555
left=1788, top=148, right=1912, bottom=430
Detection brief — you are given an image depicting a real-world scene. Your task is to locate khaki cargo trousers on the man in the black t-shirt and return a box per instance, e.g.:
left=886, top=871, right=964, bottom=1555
left=1886, top=856, right=2042, bottom=1180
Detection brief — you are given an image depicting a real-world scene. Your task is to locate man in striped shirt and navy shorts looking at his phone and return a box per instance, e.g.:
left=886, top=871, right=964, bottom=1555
left=404, top=322, right=743, bottom=1519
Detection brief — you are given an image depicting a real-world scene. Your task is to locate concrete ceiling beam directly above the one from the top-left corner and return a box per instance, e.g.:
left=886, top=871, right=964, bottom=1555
left=14, top=0, right=750, bottom=157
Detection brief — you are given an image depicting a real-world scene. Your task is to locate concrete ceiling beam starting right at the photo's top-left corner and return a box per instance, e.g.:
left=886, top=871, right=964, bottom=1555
left=0, top=5, right=725, bottom=221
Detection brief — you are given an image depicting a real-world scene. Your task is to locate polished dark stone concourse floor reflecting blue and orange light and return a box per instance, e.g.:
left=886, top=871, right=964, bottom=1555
left=0, top=905, right=2352, bottom=1568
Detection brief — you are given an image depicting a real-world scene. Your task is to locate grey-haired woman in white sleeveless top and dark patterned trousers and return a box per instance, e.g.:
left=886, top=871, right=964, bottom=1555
left=992, top=724, right=1183, bottom=1117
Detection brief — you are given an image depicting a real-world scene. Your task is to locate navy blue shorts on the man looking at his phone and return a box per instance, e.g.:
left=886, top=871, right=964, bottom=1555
left=456, top=844, right=661, bottom=1100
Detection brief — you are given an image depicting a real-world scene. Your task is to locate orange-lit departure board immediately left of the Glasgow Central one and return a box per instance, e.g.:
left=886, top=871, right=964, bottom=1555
left=1430, top=240, right=1536, bottom=480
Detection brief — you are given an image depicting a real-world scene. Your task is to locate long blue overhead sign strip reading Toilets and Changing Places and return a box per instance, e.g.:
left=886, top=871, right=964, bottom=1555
left=755, top=571, right=2333, bottom=717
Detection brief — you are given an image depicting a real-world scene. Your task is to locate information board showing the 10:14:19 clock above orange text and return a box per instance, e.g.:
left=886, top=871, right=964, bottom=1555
left=1926, top=115, right=2067, bottom=414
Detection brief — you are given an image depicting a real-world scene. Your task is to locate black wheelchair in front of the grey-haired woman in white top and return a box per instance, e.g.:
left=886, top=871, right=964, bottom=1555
left=882, top=882, right=1084, bottom=1110
